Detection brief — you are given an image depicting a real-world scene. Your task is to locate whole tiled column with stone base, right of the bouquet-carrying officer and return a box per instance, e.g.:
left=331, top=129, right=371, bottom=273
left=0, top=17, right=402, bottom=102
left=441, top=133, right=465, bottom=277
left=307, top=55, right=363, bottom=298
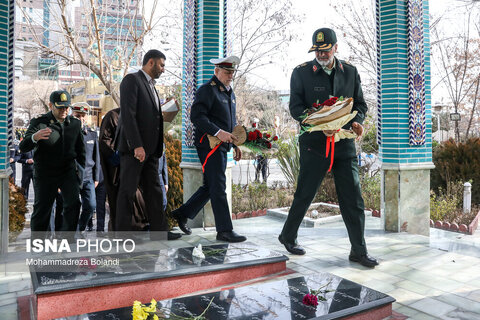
left=376, top=0, right=434, bottom=235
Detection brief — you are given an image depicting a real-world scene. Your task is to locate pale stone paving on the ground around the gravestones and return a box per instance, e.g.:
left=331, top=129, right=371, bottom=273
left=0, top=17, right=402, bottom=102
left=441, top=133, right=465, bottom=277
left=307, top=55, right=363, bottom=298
left=0, top=212, right=480, bottom=320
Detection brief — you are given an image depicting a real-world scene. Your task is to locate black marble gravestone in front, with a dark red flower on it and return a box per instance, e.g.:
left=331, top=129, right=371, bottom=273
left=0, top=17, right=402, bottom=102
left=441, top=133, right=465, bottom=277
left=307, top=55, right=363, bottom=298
left=62, top=273, right=395, bottom=320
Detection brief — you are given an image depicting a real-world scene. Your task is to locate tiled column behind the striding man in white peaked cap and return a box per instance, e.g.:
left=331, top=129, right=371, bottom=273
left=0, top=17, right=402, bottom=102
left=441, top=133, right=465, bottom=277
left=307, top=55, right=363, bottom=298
left=180, top=0, right=232, bottom=227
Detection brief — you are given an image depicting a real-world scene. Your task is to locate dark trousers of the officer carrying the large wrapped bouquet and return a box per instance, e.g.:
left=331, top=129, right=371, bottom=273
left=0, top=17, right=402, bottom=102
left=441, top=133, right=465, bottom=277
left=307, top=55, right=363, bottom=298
left=281, top=140, right=367, bottom=255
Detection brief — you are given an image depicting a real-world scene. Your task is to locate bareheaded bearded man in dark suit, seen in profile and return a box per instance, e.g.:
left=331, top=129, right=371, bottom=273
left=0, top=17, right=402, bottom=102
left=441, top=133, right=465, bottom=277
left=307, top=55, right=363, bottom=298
left=116, top=50, right=181, bottom=240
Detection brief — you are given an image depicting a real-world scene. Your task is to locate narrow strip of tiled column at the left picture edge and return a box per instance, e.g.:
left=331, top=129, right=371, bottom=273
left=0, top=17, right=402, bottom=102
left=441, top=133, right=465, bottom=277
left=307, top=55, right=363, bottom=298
left=0, top=0, right=15, bottom=254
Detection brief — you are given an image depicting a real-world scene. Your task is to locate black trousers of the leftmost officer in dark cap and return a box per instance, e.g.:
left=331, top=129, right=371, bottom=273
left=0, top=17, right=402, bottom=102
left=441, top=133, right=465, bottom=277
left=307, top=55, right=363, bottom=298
left=30, top=167, right=80, bottom=231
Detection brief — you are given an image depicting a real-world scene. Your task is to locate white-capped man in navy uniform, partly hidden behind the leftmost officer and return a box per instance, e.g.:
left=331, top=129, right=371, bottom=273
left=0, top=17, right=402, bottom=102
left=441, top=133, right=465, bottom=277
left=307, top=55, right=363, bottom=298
left=72, top=102, right=100, bottom=231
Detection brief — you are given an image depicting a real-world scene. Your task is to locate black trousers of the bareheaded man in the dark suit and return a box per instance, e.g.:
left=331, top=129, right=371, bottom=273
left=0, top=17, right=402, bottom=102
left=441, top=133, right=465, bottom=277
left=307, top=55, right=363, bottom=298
left=115, top=153, right=168, bottom=231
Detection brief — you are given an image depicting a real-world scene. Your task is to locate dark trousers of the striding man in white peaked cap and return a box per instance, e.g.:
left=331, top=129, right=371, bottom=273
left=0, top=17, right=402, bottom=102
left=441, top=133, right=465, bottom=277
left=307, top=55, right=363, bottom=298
left=178, top=147, right=233, bottom=232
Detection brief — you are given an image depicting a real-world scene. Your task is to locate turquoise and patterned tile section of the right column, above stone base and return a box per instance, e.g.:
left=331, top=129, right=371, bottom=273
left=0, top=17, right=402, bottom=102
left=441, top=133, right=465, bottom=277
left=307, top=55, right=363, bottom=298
left=376, top=0, right=432, bottom=165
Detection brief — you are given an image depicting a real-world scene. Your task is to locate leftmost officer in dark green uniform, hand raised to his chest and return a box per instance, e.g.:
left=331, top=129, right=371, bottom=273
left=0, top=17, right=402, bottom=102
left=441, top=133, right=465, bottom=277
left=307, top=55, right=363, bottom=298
left=20, top=91, right=85, bottom=232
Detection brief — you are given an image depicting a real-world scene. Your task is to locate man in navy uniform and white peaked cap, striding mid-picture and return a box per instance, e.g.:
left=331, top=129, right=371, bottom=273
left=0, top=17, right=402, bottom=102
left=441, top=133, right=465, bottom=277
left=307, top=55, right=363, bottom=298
left=172, top=56, right=247, bottom=242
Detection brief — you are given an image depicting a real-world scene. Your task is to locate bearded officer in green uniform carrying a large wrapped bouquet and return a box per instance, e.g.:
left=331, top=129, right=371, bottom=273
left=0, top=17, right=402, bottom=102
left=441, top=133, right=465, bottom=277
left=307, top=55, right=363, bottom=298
left=278, top=28, right=378, bottom=268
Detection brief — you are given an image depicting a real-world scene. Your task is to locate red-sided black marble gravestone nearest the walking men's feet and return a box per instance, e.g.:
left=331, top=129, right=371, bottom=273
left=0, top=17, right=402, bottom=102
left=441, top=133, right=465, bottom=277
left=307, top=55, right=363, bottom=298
left=30, top=242, right=288, bottom=320
